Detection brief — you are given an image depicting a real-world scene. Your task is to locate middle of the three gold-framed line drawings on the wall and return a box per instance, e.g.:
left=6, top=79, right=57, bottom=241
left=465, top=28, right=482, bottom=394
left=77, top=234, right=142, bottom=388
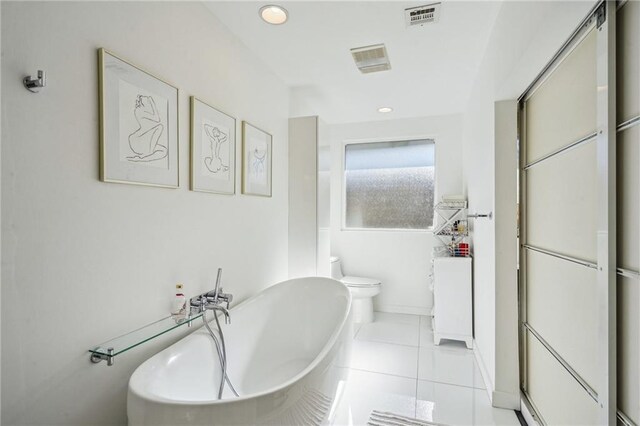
left=191, top=96, right=236, bottom=195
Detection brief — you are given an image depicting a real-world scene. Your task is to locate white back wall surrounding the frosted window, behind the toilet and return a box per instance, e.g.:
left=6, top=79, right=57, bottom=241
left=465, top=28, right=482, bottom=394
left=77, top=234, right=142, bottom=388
left=329, top=115, right=462, bottom=315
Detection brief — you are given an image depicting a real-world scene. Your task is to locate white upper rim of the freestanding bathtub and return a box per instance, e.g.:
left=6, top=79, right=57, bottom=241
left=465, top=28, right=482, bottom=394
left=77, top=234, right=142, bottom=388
left=127, top=277, right=352, bottom=406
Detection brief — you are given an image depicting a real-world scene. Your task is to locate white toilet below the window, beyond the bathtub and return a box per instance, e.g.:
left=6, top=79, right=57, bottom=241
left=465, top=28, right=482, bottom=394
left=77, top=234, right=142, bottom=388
left=330, top=256, right=381, bottom=323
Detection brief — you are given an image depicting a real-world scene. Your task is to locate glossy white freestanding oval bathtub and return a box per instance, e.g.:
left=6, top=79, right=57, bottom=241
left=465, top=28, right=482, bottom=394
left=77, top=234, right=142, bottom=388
left=127, top=277, right=353, bottom=426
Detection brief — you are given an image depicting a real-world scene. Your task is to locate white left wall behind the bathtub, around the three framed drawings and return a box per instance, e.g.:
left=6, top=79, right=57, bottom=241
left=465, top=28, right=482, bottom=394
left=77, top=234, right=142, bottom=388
left=1, top=2, right=289, bottom=425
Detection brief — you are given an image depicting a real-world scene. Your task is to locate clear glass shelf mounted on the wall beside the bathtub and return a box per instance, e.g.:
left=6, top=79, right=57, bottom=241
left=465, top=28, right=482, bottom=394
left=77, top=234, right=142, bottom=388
left=89, top=312, right=202, bottom=365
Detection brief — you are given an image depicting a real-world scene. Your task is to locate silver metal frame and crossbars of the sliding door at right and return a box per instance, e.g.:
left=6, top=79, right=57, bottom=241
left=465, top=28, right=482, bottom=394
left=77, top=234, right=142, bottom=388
left=518, top=0, right=617, bottom=425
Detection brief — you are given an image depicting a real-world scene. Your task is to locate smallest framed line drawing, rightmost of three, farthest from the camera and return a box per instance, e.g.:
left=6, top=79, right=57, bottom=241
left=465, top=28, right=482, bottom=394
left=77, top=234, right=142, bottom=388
left=242, top=121, right=272, bottom=197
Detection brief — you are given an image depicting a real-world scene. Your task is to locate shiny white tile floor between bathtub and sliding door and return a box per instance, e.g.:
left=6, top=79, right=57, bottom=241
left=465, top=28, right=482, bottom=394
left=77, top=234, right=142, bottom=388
left=333, top=312, right=520, bottom=426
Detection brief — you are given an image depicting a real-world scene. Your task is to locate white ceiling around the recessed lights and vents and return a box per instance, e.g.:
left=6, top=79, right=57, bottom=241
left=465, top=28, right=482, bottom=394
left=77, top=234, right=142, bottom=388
left=206, top=0, right=500, bottom=123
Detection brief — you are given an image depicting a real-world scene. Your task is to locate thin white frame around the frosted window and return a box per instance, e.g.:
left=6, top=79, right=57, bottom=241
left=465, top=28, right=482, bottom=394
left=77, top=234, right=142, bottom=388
left=340, top=135, right=439, bottom=234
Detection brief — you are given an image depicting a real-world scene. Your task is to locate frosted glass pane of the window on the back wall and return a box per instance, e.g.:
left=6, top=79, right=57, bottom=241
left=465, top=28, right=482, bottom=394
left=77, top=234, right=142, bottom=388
left=344, top=139, right=435, bottom=229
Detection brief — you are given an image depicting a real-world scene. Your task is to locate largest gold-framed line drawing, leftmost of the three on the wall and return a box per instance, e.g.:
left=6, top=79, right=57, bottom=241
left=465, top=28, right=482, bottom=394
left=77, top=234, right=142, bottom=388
left=98, top=49, right=179, bottom=188
